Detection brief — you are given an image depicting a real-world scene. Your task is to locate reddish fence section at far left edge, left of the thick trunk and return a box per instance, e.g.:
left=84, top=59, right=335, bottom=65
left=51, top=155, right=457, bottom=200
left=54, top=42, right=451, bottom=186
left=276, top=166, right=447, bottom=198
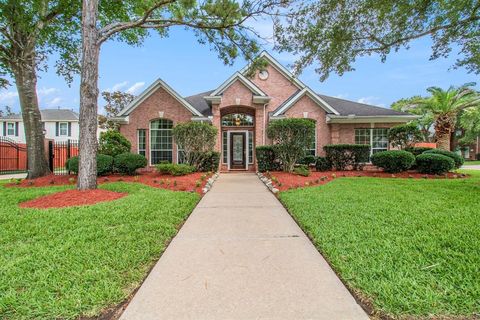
left=0, top=136, right=27, bottom=174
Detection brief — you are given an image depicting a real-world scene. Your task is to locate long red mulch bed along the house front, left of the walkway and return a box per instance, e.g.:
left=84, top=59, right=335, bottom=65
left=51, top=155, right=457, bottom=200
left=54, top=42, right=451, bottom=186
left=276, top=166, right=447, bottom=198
left=8, top=172, right=211, bottom=195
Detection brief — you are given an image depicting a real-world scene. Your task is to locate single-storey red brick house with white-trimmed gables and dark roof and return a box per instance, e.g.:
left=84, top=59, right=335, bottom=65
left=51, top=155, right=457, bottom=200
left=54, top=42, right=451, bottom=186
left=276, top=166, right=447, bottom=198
left=113, top=52, right=416, bottom=171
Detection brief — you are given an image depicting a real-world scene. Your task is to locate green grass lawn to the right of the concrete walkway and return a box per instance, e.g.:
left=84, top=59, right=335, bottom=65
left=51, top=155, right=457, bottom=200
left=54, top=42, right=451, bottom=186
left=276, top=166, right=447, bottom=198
left=280, top=171, right=480, bottom=316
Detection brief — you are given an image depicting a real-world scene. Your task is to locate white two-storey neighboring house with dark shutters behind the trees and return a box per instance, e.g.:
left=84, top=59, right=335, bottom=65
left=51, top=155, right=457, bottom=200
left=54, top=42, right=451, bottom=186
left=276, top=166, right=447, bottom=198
left=0, top=109, right=79, bottom=143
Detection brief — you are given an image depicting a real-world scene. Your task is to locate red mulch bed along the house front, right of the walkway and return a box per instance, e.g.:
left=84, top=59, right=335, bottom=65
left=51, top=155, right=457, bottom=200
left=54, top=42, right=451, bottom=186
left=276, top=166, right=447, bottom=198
left=265, top=171, right=466, bottom=191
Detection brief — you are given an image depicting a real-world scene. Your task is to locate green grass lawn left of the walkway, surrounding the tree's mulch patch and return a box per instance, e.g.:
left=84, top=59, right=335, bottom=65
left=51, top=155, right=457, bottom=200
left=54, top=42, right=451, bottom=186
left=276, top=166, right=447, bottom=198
left=0, top=182, right=199, bottom=319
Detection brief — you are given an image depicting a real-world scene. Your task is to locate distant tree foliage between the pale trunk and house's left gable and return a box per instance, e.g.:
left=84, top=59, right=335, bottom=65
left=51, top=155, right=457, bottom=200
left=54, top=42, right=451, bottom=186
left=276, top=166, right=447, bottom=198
left=98, top=91, right=135, bottom=130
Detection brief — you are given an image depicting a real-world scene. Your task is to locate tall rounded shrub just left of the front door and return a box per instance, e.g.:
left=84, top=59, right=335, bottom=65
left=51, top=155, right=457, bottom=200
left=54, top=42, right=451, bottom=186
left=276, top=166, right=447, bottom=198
left=172, top=121, right=217, bottom=170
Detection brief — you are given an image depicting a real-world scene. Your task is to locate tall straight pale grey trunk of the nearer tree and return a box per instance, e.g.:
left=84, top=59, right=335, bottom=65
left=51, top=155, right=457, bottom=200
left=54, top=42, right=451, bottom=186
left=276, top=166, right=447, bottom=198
left=77, top=0, right=100, bottom=190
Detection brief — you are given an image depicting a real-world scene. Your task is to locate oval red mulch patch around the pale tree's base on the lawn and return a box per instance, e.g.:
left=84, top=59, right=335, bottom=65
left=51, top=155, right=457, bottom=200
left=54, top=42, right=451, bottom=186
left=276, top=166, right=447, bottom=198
left=19, top=189, right=127, bottom=209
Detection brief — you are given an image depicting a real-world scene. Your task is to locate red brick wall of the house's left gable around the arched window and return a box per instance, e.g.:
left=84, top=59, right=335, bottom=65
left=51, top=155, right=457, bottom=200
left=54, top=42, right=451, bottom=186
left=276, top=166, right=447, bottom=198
left=120, top=88, right=193, bottom=163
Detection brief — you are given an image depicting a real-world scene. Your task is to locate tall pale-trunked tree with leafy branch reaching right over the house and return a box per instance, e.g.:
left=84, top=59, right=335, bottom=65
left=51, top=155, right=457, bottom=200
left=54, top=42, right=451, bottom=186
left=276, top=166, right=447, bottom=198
left=78, top=0, right=285, bottom=190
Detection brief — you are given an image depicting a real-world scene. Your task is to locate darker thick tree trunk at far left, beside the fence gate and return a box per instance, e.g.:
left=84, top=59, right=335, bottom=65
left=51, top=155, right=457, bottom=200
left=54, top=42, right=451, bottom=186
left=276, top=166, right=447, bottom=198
left=13, top=57, right=51, bottom=179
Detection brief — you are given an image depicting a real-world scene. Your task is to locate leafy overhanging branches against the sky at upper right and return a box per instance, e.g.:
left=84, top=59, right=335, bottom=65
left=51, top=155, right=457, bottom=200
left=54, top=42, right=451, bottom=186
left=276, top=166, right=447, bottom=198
left=276, top=0, right=480, bottom=80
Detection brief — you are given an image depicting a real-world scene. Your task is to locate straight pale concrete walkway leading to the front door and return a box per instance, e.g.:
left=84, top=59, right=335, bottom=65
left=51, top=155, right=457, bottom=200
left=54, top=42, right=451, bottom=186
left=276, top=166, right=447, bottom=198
left=121, top=174, right=368, bottom=320
